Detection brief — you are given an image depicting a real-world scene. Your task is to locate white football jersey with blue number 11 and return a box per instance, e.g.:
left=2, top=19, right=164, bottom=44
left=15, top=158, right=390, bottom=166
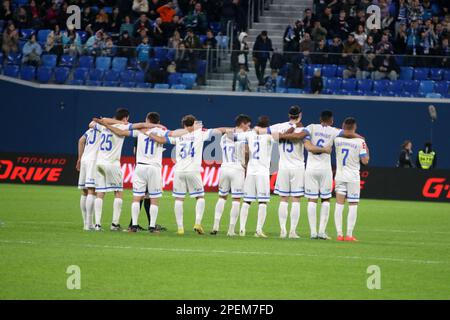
left=133, top=128, right=167, bottom=167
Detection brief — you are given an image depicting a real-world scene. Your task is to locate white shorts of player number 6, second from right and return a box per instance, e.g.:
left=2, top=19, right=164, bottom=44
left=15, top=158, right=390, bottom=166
left=305, top=169, right=333, bottom=199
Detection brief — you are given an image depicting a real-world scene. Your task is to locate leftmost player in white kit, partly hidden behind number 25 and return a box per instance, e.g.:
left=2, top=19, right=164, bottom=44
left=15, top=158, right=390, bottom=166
left=76, top=124, right=100, bottom=230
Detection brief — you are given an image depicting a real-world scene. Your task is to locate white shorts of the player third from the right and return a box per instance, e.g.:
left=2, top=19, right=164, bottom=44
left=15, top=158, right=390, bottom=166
left=275, top=168, right=305, bottom=197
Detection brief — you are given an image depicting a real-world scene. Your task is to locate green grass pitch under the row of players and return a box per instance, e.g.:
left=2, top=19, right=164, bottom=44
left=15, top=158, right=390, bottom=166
left=0, top=184, right=450, bottom=299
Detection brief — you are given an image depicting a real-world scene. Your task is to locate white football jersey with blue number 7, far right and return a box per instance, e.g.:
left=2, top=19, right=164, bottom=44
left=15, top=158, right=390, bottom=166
left=334, top=137, right=367, bottom=182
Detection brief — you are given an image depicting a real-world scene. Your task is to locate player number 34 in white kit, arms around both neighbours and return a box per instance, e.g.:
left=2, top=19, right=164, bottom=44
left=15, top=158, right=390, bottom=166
left=150, top=115, right=231, bottom=235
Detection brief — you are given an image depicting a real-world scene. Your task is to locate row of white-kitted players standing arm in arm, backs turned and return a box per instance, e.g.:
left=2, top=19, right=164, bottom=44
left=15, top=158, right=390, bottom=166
left=77, top=106, right=369, bottom=241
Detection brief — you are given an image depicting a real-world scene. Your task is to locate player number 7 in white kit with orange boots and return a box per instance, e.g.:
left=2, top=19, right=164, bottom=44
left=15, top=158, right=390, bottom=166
left=334, top=118, right=369, bottom=241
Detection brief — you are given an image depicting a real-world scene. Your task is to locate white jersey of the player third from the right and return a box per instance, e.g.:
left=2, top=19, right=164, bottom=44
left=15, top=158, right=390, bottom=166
left=270, top=122, right=306, bottom=169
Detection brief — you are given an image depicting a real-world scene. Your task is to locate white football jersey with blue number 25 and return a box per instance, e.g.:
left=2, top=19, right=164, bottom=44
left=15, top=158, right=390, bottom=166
left=95, top=123, right=132, bottom=164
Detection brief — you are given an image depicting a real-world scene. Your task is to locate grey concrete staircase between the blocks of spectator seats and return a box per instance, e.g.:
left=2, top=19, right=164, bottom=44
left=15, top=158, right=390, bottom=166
left=199, top=0, right=313, bottom=91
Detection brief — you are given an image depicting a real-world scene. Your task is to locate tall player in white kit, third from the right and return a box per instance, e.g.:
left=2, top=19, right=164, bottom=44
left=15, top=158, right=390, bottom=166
left=263, top=106, right=331, bottom=239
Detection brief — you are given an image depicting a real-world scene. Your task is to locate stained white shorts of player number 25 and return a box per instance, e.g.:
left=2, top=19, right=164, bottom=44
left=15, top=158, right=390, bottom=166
left=95, top=164, right=123, bottom=192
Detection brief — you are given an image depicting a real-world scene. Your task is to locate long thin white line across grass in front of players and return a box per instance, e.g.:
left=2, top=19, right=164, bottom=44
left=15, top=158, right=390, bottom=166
left=0, top=239, right=450, bottom=264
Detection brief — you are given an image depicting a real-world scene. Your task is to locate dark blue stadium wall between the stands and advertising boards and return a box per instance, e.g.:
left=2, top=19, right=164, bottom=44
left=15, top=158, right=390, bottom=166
left=0, top=76, right=450, bottom=169
